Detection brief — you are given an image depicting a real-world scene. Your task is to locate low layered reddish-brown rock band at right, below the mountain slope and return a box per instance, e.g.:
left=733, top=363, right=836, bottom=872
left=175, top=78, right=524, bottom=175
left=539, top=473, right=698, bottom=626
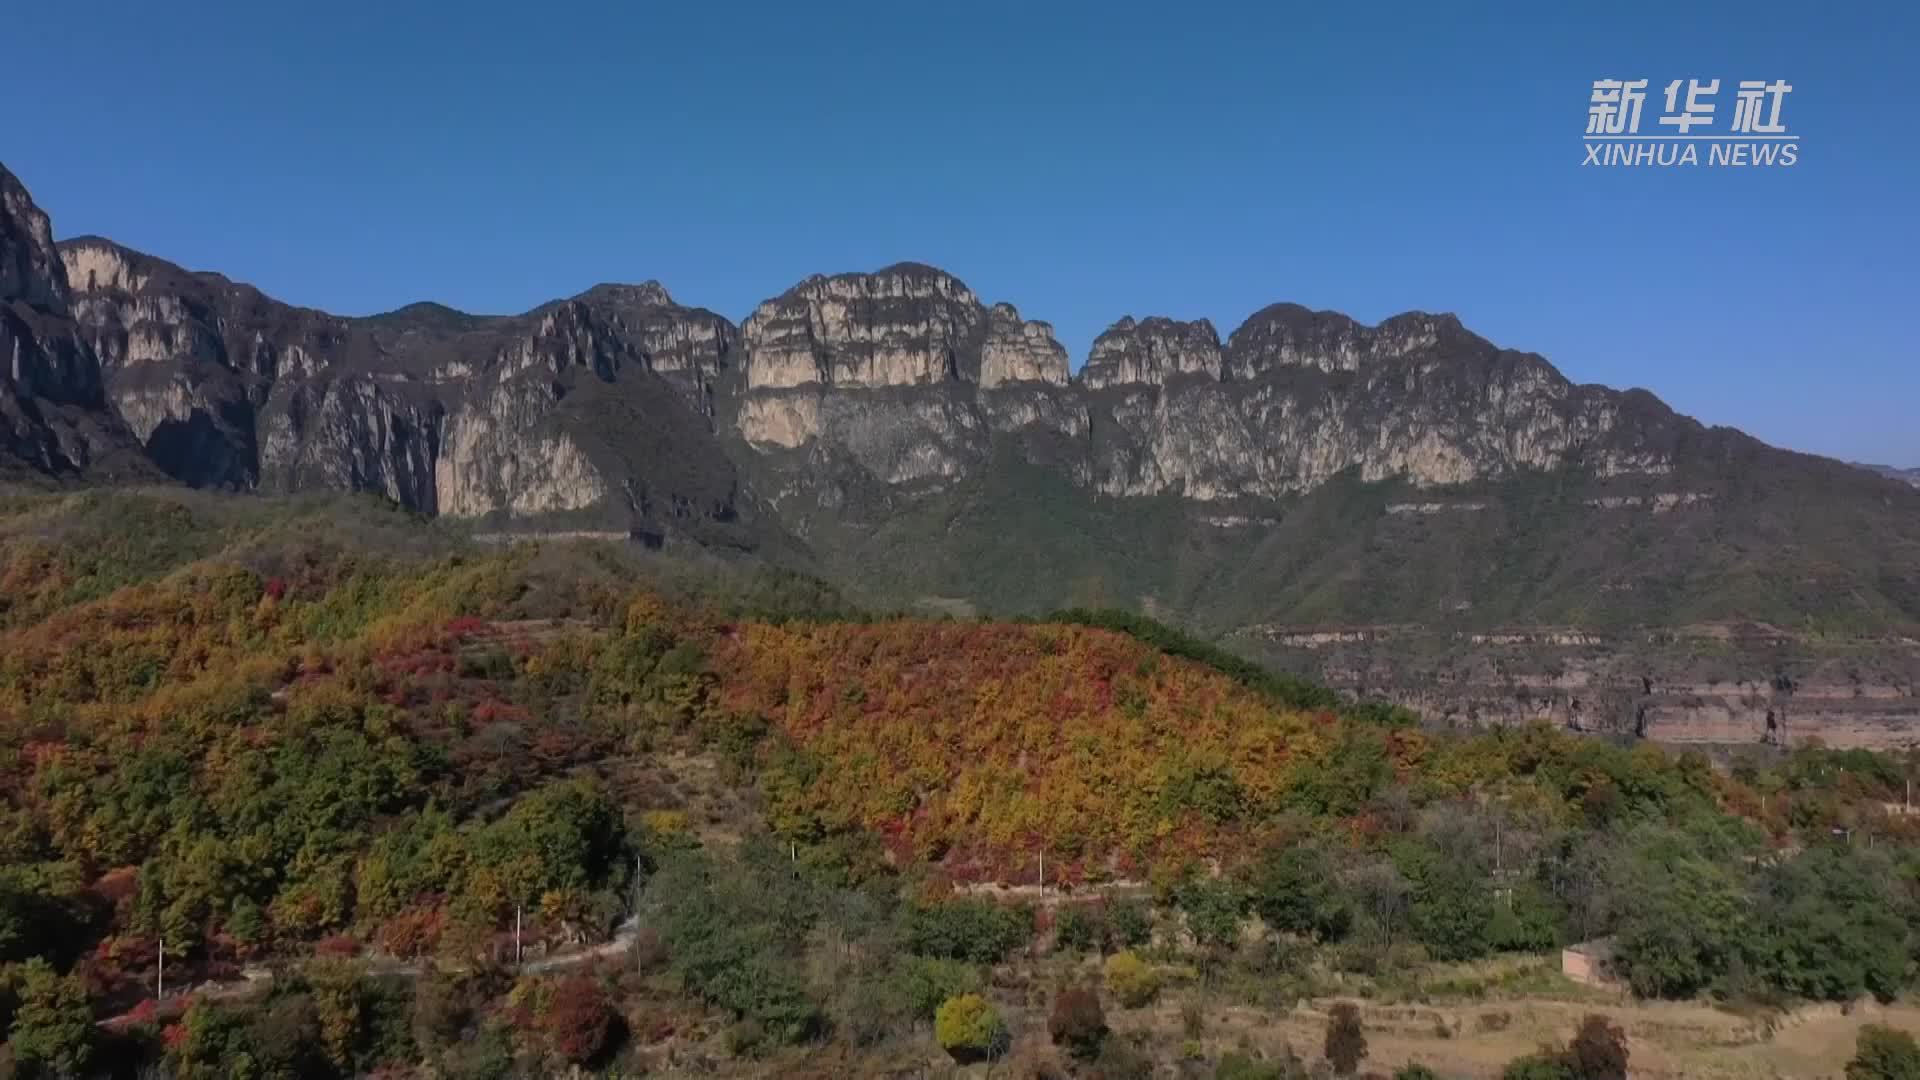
left=1242, top=625, right=1920, bottom=751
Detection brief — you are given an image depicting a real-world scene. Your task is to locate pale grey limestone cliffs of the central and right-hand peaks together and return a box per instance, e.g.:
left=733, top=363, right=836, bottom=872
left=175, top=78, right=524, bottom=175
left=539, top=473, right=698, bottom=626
left=728, top=265, right=1699, bottom=500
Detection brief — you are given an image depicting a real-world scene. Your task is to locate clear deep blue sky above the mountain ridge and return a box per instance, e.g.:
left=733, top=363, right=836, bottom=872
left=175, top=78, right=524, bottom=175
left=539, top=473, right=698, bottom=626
left=0, top=0, right=1920, bottom=457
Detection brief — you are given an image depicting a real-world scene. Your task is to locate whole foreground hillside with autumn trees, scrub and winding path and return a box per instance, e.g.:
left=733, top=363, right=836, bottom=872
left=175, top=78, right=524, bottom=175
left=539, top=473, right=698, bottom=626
left=0, top=492, right=1920, bottom=1076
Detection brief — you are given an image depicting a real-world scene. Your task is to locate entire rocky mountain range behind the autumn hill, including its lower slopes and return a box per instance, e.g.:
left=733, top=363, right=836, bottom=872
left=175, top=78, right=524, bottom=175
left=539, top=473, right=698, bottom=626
left=11, top=159, right=1920, bottom=744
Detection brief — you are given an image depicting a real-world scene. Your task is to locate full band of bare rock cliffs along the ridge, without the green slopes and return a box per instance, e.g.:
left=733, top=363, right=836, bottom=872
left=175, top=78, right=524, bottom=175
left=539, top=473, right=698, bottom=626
left=15, top=139, right=1695, bottom=521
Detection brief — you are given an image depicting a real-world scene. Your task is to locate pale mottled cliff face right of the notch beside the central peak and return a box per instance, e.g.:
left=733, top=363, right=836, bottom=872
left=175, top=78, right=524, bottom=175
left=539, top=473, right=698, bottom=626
left=1100, top=325, right=1643, bottom=500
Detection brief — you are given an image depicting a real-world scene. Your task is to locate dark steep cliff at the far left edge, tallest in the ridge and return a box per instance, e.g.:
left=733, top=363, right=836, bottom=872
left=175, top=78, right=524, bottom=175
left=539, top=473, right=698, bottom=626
left=0, top=167, right=152, bottom=479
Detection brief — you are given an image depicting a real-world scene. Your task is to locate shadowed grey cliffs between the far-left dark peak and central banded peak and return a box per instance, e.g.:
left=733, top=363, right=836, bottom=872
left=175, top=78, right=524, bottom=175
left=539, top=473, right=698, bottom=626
left=60, top=225, right=739, bottom=534
